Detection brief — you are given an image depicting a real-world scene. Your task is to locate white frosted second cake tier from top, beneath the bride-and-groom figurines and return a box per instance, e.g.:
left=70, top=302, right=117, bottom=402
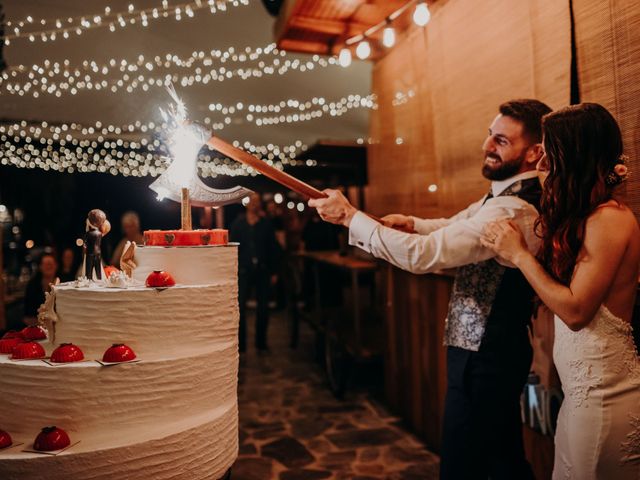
left=48, top=282, right=238, bottom=360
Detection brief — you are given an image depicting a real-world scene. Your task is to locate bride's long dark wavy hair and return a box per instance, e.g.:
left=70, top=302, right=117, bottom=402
left=536, top=103, right=622, bottom=285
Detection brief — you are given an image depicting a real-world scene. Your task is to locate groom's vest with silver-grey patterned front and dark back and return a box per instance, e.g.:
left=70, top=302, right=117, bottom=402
left=444, top=178, right=541, bottom=351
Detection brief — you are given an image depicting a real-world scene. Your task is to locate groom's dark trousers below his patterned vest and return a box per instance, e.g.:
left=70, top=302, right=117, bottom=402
left=440, top=300, right=533, bottom=480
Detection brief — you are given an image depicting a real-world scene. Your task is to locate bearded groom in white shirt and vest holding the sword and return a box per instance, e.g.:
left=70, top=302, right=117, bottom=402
left=309, top=99, right=551, bottom=480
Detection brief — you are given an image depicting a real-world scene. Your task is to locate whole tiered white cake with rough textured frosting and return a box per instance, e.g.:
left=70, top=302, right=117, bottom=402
left=0, top=245, right=238, bottom=480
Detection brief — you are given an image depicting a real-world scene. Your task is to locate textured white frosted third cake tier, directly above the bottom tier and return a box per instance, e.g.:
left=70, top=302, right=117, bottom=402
left=0, top=342, right=238, bottom=441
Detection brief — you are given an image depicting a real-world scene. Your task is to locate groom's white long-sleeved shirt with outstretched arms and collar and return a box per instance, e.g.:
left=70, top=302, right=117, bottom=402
left=349, top=171, right=540, bottom=273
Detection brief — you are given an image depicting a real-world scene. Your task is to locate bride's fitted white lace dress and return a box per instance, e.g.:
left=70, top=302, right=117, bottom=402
left=553, top=305, right=640, bottom=480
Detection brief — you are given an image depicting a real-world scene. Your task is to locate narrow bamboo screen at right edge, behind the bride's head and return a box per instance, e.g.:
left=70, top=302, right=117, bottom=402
left=573, top=0, right=640, bottom=220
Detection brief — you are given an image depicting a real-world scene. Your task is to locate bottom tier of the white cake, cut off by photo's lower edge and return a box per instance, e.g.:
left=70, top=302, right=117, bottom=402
left=0, top=402, right=238, bottom=480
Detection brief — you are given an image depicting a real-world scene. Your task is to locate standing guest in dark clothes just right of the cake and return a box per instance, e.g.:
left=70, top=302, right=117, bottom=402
left=229, top=193, right=281, bottom=353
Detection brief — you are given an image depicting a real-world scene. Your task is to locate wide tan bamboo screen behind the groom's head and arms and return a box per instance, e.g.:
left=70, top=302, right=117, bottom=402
left=367, top=0, right=571, bottom=217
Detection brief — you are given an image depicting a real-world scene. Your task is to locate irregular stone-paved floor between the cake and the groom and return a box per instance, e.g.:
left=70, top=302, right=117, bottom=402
left=231, top=314, right=439, bottom=480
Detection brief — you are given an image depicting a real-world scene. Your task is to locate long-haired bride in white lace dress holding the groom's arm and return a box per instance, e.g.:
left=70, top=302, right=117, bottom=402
left=482, top=103, right=640, bottom=480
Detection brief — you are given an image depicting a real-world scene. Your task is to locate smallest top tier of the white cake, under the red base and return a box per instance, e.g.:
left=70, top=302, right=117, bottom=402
left=133, top=244, right=238, bottom=285
